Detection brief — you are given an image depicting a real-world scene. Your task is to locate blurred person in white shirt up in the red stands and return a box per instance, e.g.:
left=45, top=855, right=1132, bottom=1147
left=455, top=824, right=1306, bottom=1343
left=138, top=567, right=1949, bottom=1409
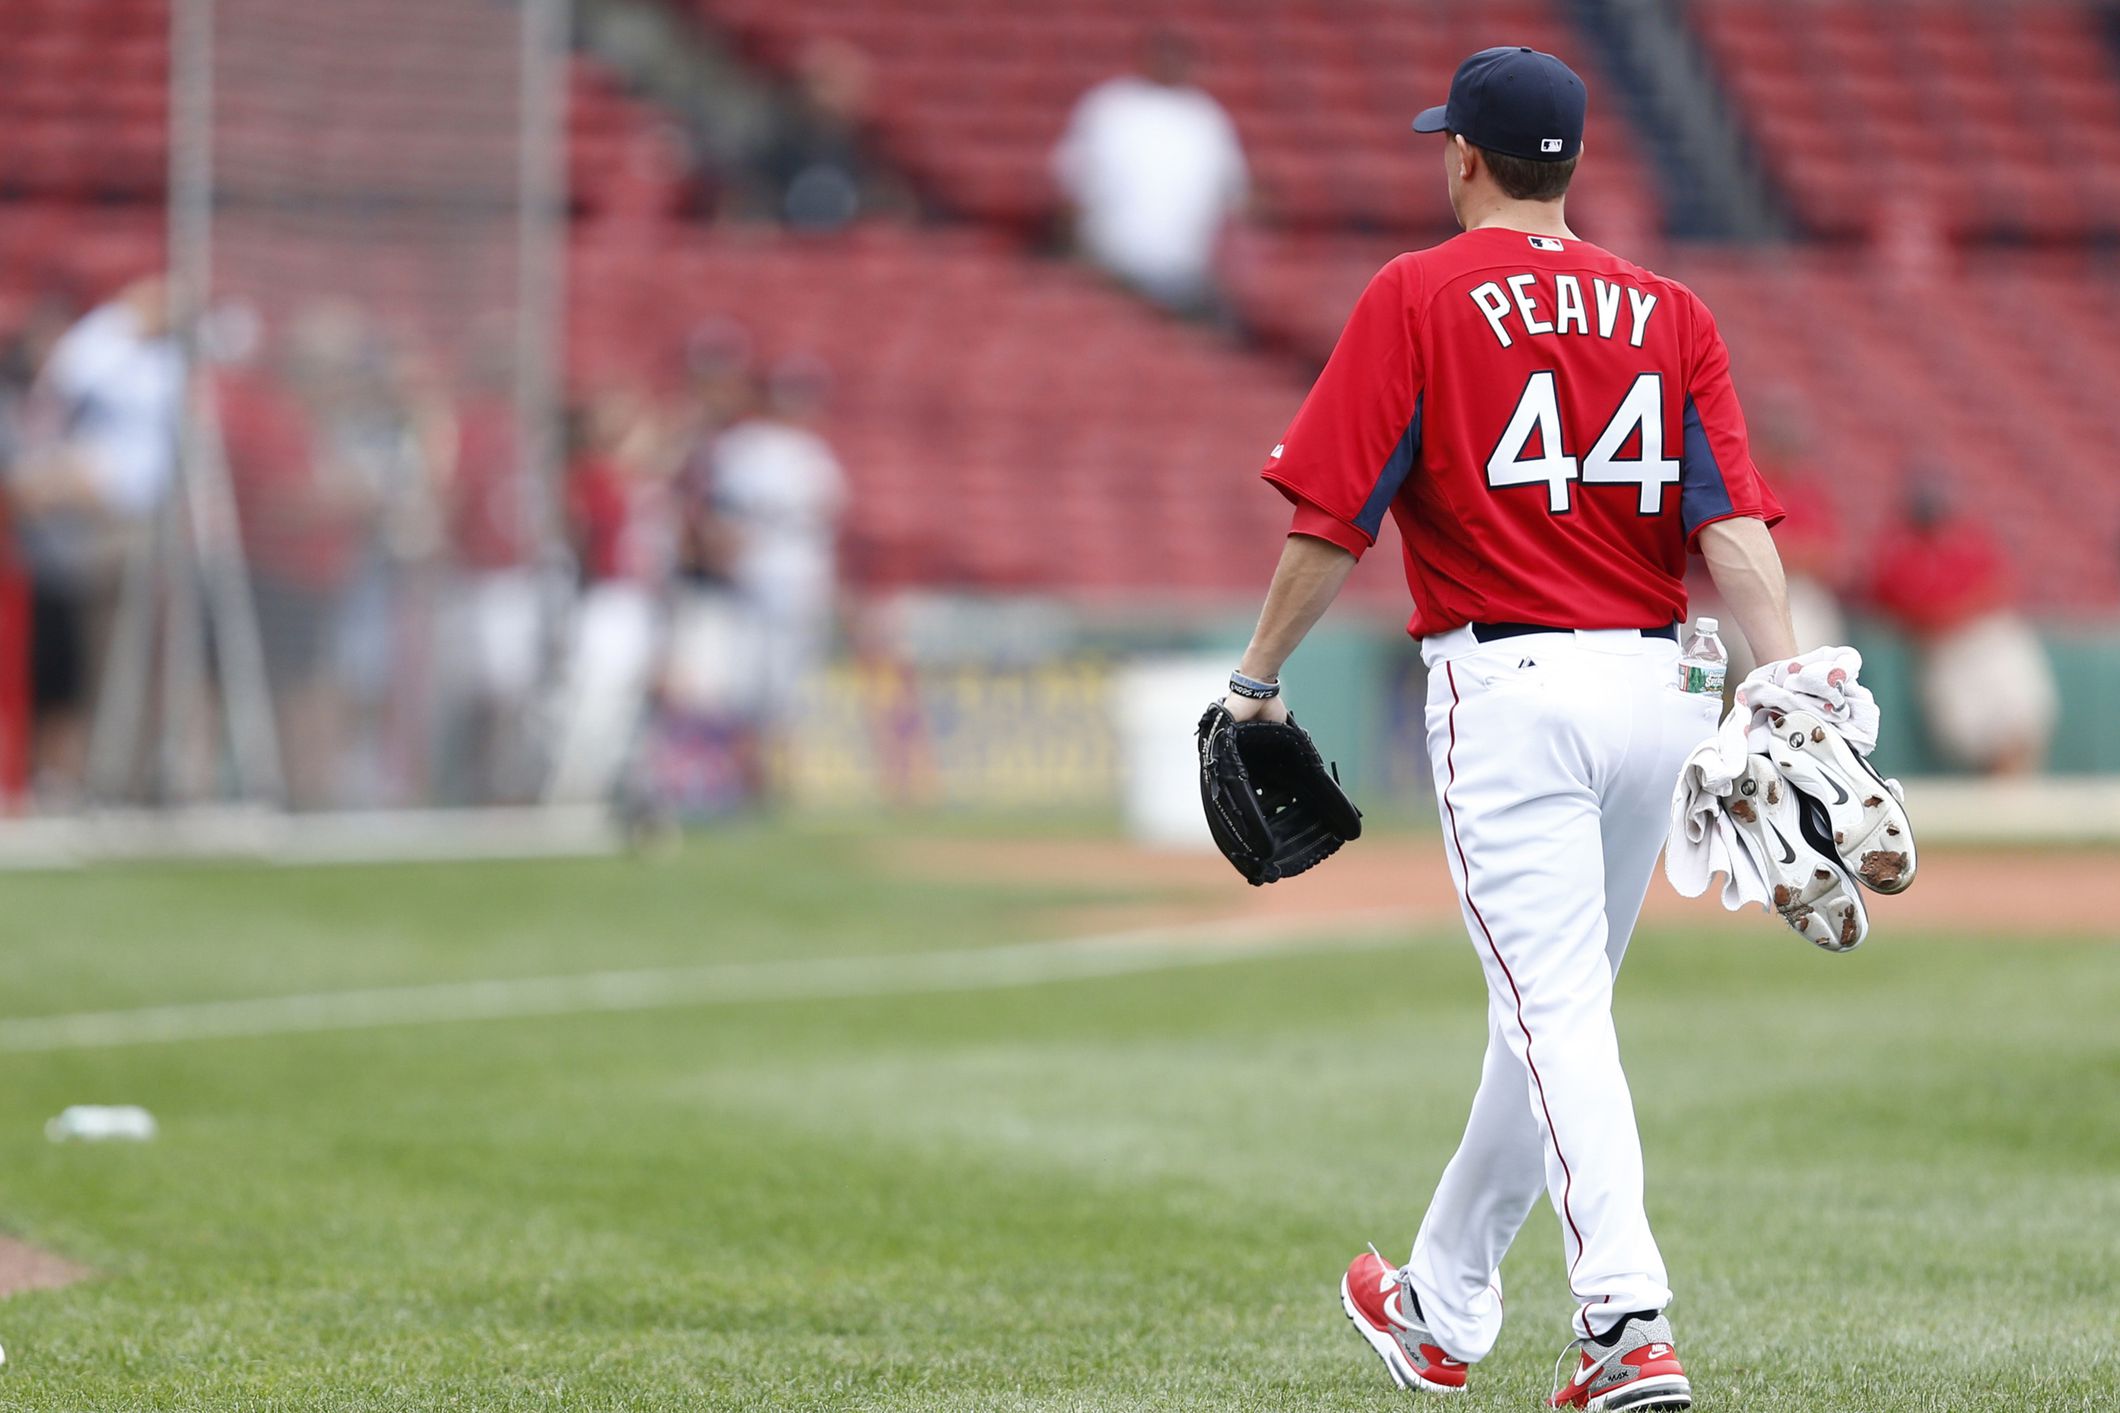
left=1052, top=30, right=1249, bottom=314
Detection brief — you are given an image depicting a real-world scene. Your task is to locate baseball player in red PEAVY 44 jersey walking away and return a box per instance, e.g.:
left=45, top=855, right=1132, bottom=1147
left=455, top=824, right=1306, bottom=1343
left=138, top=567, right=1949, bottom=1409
left=1225, top=49, right=1796, bottom=1411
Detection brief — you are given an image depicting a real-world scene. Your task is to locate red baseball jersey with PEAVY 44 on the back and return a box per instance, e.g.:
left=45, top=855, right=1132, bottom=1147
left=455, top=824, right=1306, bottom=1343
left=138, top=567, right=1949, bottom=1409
left=1264, top=227, right=1781, bottom=636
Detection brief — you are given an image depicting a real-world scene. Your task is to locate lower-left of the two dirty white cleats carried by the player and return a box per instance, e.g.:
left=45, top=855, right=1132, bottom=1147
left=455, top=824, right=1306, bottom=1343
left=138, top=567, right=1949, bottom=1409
left=1721, top=756, right=1870, bottom=951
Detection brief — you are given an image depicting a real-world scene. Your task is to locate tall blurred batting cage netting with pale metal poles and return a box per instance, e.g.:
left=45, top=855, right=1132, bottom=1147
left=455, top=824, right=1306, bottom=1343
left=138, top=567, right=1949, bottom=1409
left=91, top=0, right=568, bottom=811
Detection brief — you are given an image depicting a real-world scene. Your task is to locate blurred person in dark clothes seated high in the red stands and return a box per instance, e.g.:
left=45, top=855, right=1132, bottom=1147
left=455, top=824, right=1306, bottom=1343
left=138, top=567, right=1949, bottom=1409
left=753, top=40, right=912, bottom=231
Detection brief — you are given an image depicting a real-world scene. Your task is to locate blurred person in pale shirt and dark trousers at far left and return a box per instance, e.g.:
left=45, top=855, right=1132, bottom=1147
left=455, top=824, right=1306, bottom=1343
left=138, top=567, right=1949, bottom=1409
left=8, top=275, right=184, bottom=803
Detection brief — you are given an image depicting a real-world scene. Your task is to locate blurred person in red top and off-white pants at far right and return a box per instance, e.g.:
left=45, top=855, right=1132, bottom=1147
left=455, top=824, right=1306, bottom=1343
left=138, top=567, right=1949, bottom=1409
left=1870, top=472, right=2059, bottom=775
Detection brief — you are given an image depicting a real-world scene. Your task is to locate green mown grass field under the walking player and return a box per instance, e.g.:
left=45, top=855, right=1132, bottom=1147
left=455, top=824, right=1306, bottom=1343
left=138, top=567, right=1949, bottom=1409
left=0, top=830, right=2120, bottom=1411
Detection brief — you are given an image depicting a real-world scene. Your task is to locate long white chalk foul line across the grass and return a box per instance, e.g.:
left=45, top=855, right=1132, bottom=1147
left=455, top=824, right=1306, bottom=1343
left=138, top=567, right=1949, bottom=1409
left=0, top=909, right=1418, bottom=1055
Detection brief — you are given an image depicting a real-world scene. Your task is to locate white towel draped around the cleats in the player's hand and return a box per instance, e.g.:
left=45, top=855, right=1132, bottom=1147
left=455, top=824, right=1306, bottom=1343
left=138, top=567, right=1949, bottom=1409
left=1664, top=648, right=1878, bottom=913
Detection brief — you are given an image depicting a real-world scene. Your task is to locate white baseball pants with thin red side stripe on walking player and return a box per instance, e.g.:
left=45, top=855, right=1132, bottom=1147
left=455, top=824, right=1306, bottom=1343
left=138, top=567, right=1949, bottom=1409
left=1408, top=629, right=1721, bottom=1362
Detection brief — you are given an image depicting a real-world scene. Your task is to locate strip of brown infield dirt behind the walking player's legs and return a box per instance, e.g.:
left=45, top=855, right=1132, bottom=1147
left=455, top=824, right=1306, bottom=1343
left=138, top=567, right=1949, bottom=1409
left=888, top=835, right=2120, bottom=941
